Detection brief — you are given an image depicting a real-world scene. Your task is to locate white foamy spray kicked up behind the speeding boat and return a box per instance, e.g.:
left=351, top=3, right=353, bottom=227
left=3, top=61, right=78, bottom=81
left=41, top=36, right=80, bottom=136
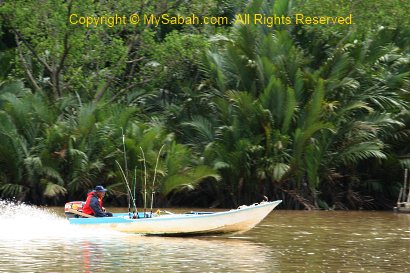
left=0, top=200, right=121, bottom=241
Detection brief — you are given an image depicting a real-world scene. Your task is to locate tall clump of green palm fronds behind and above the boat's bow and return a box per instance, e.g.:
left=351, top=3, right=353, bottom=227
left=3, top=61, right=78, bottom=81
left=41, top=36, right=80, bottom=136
left=195, top=1, right=409, bottom=206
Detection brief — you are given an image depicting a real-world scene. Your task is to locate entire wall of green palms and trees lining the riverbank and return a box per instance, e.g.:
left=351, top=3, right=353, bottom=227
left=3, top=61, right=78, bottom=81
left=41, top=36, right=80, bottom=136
left=0, top=0, right=410, bottom=209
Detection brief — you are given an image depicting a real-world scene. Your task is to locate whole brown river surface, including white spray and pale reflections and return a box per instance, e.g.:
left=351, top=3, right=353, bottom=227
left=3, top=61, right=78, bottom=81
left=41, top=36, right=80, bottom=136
left=0, top=201, right=410, bottom=273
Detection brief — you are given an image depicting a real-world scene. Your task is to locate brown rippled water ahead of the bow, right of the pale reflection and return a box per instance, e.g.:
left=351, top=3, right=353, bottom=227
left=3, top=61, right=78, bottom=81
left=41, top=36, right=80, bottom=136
left=248, top=211, right=410, bottom=272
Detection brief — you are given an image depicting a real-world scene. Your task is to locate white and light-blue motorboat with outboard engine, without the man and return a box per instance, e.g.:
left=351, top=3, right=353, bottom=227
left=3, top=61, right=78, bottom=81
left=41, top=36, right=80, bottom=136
left=65, top=200, right=282, bottom=236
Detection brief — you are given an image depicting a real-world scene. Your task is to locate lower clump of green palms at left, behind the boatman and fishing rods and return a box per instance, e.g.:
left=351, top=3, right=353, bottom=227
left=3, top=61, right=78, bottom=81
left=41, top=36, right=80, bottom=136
left=0, top=77, right=219, bottom=203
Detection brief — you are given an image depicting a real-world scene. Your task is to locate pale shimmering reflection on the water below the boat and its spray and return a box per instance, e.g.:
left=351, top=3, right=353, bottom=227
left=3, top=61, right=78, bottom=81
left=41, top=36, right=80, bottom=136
left=0, top=233, right=276, bottom=272
